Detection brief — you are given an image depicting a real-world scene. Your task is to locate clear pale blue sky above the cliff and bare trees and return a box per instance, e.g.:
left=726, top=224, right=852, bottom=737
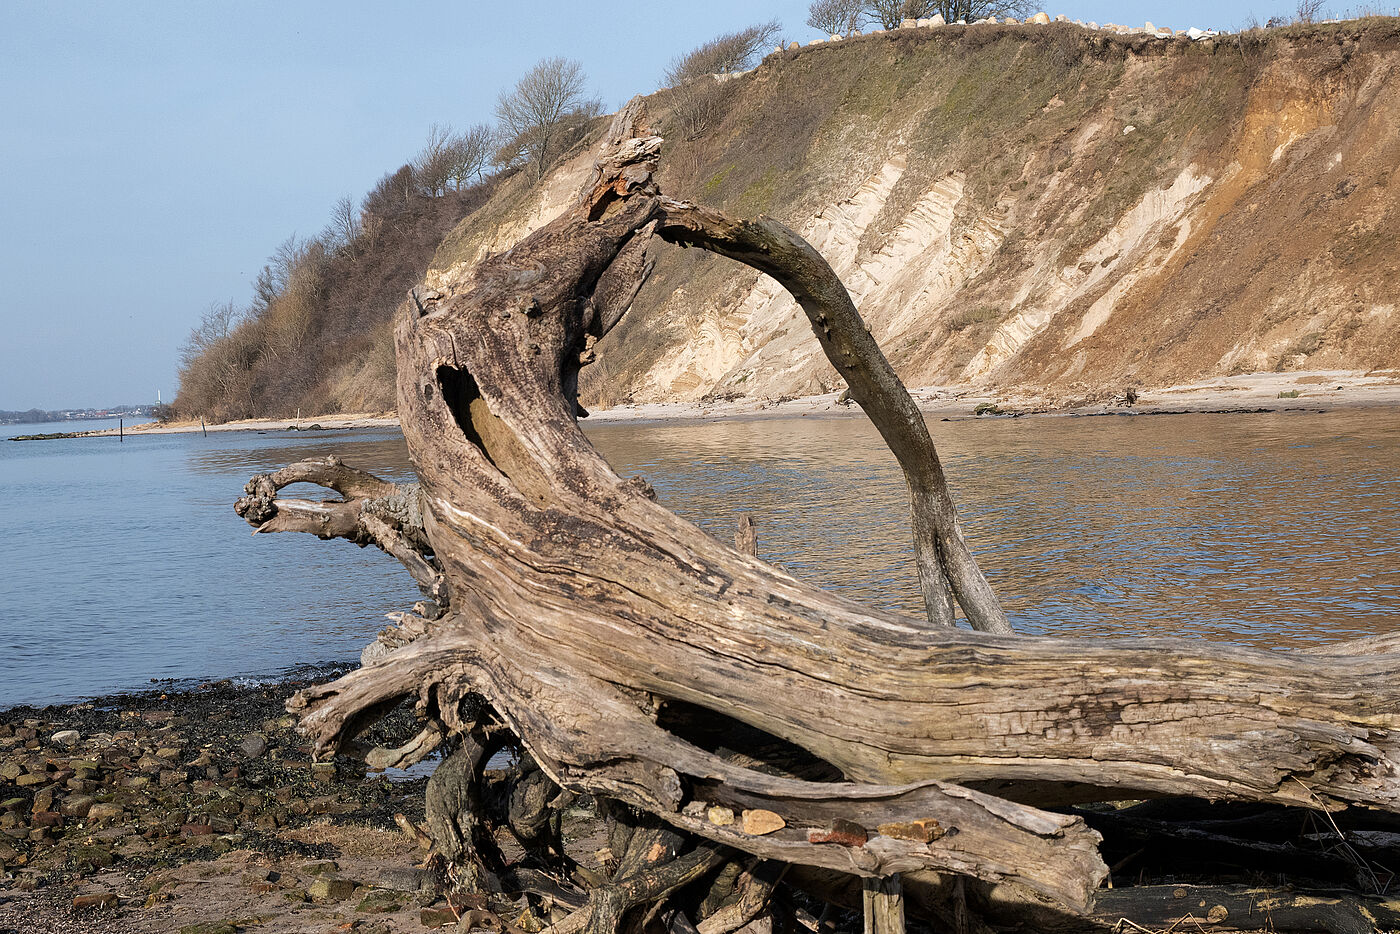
left=0, top=0, right=1292, bottom=410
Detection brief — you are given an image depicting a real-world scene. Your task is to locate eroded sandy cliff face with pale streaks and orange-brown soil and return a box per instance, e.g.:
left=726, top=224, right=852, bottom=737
left=430, top=20, right=1400, bottom=406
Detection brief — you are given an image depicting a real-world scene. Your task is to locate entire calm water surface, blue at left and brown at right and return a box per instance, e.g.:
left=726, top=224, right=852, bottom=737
left=0, top=410, right=1400, bottom=706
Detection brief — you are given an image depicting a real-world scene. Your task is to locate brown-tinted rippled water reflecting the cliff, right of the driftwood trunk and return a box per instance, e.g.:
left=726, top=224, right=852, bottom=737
left=589, top=409, right=1400, bottom=647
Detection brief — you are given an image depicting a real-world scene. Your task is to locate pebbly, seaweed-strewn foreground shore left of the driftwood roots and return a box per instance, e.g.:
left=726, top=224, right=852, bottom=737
left=0, top=671, right=445, bottom=934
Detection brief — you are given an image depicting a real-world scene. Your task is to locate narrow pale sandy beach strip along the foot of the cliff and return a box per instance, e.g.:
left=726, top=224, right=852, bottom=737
left=71, top=370, right=1400, bottom=437
